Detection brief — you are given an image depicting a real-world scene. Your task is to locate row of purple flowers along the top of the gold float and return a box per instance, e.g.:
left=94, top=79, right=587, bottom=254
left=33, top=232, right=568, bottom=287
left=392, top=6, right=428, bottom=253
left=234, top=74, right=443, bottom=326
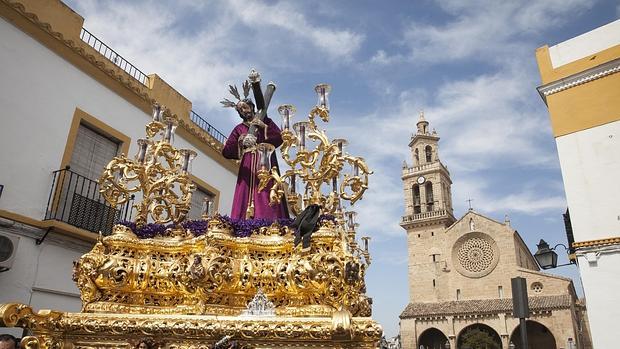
left=118, top=214, right=336, bottom=239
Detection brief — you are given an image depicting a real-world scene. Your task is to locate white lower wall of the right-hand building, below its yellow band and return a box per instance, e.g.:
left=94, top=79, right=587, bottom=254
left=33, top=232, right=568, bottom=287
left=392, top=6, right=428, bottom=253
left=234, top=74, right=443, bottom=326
left=556, top=121, right=620, bottom=348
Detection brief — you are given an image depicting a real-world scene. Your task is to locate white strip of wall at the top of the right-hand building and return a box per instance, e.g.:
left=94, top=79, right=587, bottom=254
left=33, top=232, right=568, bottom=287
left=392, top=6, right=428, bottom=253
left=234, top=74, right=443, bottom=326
left=549, top=19, right=620, bottom=68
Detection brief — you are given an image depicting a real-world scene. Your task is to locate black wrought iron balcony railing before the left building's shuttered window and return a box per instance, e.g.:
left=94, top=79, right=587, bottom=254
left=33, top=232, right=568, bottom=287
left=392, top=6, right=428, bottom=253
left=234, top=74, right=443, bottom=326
left=45, top=166, right=133, bottom=235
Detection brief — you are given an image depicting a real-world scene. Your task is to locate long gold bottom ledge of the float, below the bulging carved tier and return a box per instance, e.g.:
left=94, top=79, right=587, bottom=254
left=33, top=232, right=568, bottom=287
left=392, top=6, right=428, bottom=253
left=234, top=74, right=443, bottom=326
left=0, top=304, right=382, bottom=349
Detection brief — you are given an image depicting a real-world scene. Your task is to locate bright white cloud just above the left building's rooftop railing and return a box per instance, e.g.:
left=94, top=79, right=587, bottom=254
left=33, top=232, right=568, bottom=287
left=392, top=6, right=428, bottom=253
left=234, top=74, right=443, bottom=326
left=72, top=1, right=245, bottom=118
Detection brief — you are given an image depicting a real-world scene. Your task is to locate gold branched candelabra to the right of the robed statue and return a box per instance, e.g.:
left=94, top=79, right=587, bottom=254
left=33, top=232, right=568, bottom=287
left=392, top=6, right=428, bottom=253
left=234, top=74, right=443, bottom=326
left=259, top=84, right=372, bottom=214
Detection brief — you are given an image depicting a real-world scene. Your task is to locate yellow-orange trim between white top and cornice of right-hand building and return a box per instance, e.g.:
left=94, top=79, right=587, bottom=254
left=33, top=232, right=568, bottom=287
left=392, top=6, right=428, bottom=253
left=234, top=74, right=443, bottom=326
left=536, top=45, right=620, bottom=85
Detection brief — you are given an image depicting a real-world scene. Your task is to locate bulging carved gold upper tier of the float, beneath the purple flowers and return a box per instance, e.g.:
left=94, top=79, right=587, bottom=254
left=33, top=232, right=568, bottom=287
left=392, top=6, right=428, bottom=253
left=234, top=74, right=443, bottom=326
left=74, top=220, right=371, bottom=316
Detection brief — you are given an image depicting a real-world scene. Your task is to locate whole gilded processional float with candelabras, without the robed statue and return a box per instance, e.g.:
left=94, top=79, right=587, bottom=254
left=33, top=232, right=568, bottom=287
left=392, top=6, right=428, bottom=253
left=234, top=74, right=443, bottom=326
left=0, top=71, right=382, bottom=349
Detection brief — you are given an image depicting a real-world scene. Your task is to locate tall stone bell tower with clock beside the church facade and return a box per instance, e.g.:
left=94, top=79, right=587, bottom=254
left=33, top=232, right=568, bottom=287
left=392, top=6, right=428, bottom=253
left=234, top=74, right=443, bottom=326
left=400, top=112, right=455, bottom=302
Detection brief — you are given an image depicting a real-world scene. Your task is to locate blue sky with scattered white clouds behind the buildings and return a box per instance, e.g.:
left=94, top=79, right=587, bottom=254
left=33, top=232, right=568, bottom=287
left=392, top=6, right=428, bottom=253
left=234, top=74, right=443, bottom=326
left=67, top=0, right=620, bottom=336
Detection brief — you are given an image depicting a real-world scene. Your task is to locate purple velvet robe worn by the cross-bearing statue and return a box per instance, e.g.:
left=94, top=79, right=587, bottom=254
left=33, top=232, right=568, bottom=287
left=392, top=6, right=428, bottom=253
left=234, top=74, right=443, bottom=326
left=222, top=117, right=289, bottom=219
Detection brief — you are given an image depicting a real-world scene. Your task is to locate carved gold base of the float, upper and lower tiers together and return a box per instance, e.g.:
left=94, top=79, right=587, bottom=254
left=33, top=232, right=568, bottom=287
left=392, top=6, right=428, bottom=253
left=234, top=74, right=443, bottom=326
left=0, top=222, right=382, bottom=348
